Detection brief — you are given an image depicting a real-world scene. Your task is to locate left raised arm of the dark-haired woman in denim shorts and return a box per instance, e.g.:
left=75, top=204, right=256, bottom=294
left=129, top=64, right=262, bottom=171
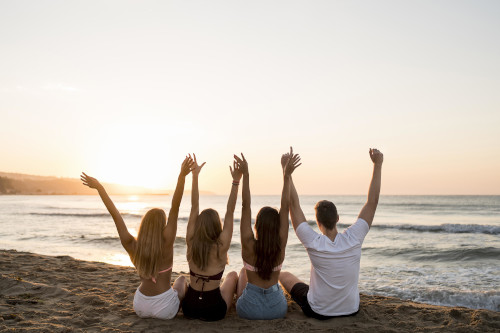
left=237, top=154, right=255, bottom=253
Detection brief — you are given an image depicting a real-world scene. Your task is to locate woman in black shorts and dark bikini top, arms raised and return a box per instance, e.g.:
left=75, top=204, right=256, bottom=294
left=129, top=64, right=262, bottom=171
left=182, top=154, right=241, bottom=321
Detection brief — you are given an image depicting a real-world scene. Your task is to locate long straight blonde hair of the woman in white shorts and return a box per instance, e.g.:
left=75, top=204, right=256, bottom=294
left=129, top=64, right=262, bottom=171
left=131, top=208, right=167, bottom=279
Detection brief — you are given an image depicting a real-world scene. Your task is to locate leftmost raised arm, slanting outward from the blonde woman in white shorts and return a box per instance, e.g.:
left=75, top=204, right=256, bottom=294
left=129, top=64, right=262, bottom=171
left=80, top=172, right=135, bottom=253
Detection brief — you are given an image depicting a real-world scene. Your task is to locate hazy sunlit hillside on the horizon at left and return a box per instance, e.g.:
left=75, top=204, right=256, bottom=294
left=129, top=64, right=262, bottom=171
left=0, top=172, right=172, bottom=195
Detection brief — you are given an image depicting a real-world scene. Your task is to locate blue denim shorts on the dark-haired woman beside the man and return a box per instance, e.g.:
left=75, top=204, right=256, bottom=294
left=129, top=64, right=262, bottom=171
left=236, top=283, right=288, bottom=319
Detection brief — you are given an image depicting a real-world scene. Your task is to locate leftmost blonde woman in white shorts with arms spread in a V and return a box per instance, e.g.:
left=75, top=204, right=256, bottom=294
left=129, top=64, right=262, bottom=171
left=80, top=156, right=193, bottom=319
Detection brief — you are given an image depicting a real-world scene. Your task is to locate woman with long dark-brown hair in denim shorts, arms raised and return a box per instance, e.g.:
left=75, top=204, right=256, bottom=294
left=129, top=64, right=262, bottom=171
left=236, top=147, right=300, bottom=319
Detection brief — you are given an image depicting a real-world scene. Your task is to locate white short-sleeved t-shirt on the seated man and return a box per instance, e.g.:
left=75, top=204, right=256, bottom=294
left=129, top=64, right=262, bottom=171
left=296, top=218, right=370, bottom=316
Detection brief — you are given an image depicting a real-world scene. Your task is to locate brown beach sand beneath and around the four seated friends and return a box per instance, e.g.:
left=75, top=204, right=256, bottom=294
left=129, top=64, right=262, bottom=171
left=0, top=250, right=500, bottom=333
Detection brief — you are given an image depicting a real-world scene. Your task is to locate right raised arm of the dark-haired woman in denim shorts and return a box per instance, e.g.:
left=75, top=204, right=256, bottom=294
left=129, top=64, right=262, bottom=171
left=280, top=147, right=301, bottom=249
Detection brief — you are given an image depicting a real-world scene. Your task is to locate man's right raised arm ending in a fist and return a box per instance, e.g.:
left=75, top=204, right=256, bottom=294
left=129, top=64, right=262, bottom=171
left=358, top=148, right=384, bottom=227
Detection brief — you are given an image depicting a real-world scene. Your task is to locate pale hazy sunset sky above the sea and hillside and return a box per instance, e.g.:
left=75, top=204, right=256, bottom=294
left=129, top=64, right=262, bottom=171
left=0, top=0, right=500, bottom=194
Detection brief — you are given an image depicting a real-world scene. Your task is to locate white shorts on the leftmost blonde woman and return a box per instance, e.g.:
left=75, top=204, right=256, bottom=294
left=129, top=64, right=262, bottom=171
left=134, top=288, right=181, bottom=319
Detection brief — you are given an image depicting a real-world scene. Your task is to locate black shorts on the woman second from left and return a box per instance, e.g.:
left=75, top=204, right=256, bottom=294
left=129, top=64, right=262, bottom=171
left=182, top=286, right=227, bottom=321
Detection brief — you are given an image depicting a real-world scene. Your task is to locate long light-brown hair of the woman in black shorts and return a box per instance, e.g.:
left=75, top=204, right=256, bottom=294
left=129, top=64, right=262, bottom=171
left=190, top=208, right=222, bottom=270
